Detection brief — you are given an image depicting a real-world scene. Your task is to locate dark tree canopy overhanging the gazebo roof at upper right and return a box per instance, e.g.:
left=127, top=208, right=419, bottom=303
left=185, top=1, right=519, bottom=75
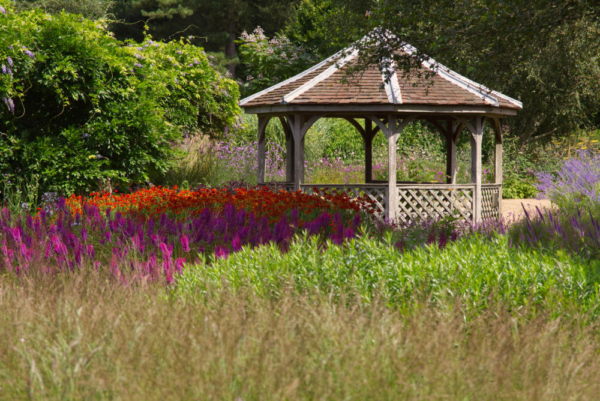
left=286, top=0, right=600, bottom=143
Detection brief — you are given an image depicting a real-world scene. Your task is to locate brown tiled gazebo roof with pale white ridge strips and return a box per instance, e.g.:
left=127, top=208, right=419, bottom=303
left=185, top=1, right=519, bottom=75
left=240, top=45, right=523, bottom=114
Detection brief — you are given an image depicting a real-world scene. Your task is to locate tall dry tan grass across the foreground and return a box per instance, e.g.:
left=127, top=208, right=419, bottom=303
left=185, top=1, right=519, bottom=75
left=0, top=275, right=600, bottom=400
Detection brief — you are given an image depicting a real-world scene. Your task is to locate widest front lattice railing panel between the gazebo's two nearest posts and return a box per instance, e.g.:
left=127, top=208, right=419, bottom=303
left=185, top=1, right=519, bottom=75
left=398, top=188, right=473, bottom=222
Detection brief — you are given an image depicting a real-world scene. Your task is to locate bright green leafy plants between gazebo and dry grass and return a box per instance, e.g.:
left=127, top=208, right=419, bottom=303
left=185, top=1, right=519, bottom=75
left=177, top=236, right=600, bottom=315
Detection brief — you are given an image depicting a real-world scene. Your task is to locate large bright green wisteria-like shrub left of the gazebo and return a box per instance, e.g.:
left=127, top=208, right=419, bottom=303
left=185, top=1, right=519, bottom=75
left=0, top=1, right=239, bottom=194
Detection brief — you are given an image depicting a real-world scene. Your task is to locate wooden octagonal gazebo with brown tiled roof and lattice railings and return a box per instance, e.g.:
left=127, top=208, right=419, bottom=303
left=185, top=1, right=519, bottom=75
left=240, top=42, right=522, bottom=223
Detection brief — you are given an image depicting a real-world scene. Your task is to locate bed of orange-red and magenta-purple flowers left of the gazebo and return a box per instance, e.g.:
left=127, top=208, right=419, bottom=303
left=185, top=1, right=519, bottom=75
left=0, top=188, right=378, bottom=283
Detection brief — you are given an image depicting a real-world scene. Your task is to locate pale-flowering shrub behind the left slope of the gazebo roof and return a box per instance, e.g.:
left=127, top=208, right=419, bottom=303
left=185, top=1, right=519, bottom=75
left=238, top=27, right=319, bottom=95
